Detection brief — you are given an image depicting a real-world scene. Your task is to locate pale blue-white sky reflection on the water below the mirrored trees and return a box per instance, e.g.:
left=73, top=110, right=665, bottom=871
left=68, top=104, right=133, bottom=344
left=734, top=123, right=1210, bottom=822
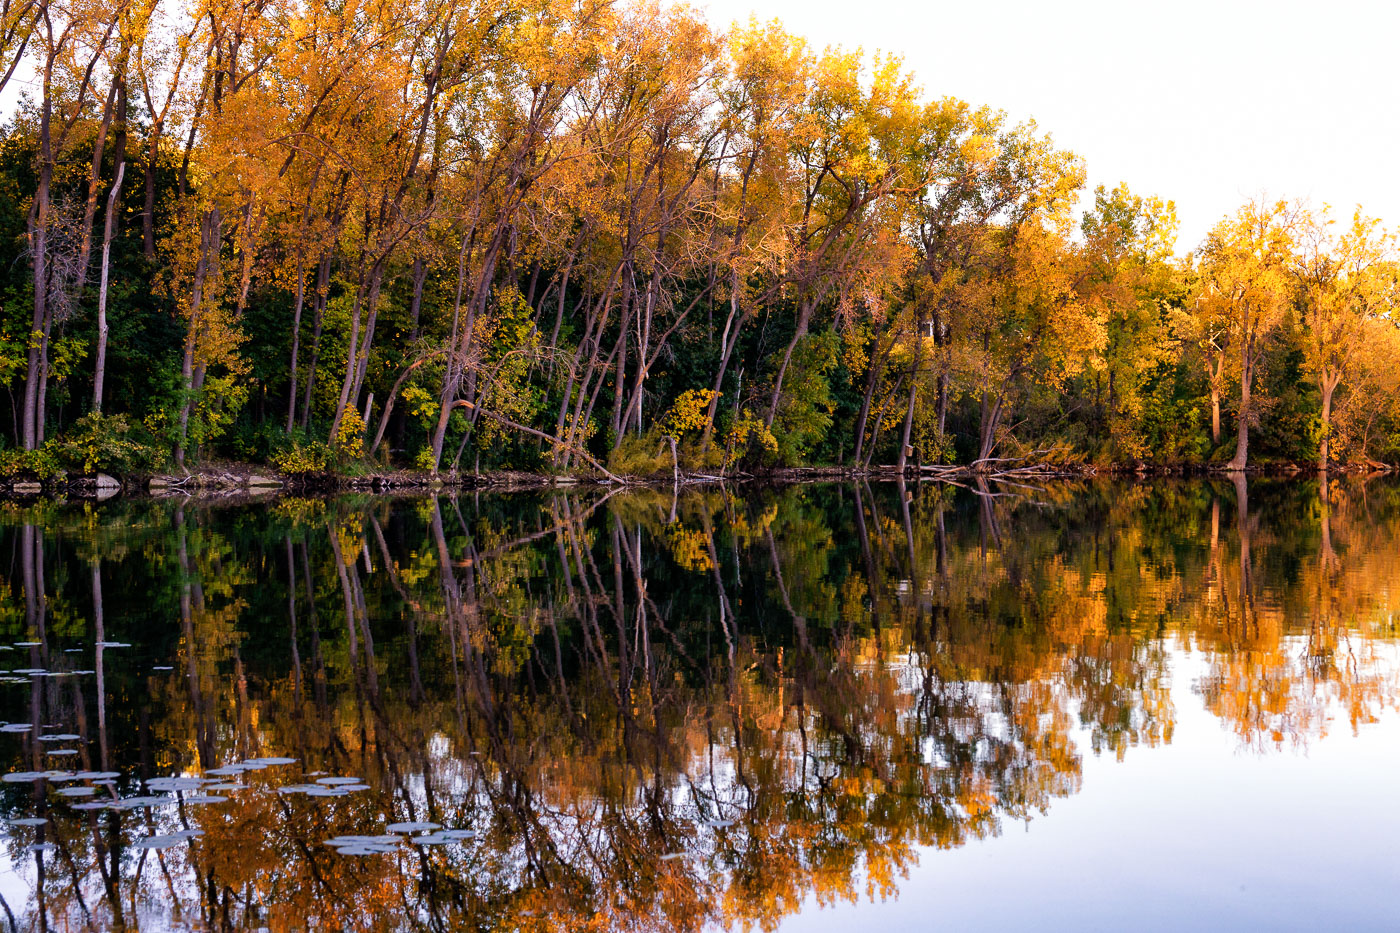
left=780, top=642, right=1400, bottom=933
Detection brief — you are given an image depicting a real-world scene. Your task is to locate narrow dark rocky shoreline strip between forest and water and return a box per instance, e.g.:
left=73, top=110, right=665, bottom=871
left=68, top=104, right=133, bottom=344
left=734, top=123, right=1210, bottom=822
left=0, top=461, right=1397, bottom=502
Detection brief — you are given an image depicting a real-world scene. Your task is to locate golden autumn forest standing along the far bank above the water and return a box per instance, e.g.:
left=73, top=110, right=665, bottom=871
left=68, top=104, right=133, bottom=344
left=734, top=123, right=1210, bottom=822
left=0, top=0, right=1400, bottom=476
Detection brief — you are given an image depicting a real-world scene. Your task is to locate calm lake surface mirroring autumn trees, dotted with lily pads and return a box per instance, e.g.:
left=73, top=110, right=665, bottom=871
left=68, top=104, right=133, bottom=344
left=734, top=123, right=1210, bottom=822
left=0, top=481, right=1400, bottom=933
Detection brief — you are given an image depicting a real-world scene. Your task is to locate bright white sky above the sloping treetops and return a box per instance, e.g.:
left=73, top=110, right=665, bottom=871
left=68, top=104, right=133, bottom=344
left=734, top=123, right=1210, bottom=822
left=696, top=0, right=1400, bottom=252
